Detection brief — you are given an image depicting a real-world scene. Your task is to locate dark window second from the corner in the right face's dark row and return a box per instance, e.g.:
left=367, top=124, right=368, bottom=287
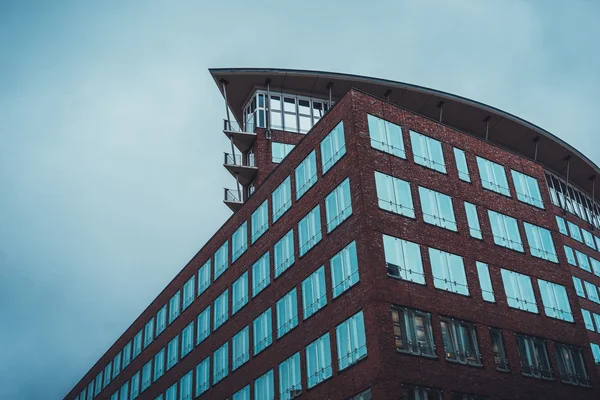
left=441, top=318, right=481, bottom=365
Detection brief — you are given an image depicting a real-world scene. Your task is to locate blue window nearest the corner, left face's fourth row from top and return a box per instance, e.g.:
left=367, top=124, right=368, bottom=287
left=335, top=311, right=367, bottom=371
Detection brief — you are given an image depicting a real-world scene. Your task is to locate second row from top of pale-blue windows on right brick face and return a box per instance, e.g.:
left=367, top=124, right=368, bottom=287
left=375, top=171, right=558, bottom=263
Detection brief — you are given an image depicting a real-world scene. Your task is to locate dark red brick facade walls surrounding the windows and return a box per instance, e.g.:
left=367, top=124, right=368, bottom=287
left=65, top=90, right=600, bottom=400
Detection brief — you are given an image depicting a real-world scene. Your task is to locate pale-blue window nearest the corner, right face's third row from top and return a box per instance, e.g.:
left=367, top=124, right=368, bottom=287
left=383, top=235, right=425, bottom=285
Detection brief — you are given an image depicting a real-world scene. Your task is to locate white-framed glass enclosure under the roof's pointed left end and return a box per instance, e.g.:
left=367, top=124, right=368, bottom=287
left=242, top=90, right=330, bottom=133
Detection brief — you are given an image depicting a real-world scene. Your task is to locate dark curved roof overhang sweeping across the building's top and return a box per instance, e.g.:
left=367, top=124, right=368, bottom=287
left=209, top=68, right=600, bottom=202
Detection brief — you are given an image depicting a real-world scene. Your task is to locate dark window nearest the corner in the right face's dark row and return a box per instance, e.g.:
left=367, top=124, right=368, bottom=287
left=392, top=308, right=435, bottom=357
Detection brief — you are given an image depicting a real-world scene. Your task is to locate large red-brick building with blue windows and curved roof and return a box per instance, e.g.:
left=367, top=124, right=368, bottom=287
left=65, top=69, right=600, bottom=400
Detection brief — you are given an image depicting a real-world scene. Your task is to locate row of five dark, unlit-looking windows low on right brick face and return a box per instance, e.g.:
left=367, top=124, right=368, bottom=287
left=392, top=307, right=590, bottom=386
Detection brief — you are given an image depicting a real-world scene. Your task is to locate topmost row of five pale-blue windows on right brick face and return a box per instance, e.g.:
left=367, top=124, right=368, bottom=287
left=367, top=114, right=544, bottom=208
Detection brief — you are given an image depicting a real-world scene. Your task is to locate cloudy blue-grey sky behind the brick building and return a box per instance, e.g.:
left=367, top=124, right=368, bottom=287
left=0, top=0, right=600, bottom=400
